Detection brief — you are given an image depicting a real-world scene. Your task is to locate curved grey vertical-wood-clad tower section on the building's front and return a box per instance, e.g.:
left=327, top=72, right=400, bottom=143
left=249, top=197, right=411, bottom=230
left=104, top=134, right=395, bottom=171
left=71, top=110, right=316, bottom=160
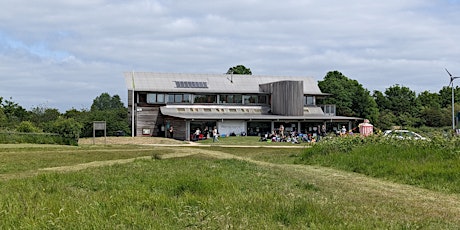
left=260, top=81, right=304, bottom=116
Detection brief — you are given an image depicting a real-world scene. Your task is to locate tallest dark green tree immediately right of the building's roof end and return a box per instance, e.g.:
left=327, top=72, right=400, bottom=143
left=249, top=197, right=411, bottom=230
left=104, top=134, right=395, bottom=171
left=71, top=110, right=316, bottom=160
left=318, top=71, right=379, bottom=122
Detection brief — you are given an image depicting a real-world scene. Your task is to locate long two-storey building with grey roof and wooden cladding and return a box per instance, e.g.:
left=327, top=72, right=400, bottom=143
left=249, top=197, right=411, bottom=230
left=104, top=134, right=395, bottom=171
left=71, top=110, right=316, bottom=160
left=124, top=72, right=363, bottom=140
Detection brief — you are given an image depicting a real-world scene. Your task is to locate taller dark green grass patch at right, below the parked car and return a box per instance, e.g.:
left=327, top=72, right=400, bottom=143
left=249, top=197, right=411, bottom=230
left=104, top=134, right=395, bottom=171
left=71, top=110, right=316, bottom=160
left=296, top=137, right=460, bottom=193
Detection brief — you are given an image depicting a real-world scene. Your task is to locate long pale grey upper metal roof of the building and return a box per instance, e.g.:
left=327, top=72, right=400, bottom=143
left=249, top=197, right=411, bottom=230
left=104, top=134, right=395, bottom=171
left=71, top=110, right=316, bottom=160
left=124, top=72, right=326, bottom=95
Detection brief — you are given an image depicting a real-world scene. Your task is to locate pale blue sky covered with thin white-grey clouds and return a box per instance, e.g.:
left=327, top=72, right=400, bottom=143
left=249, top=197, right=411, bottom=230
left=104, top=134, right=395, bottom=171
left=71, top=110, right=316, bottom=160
left=0, top=0, right=460, bottom=112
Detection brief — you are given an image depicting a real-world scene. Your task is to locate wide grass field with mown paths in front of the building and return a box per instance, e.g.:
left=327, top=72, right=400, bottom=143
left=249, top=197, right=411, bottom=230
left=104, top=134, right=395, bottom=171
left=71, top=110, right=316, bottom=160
left=0, top=139, right=460, bottom=229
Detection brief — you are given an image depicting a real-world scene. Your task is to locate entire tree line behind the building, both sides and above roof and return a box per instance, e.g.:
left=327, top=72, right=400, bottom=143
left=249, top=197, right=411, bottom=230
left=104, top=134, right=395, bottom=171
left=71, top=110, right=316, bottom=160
left=0, top=69, right=460, bottom=141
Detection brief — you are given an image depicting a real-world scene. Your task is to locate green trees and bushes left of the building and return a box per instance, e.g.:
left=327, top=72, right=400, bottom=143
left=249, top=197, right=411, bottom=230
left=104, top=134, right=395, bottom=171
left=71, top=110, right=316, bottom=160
left=0, top=93, right=131, bottom=139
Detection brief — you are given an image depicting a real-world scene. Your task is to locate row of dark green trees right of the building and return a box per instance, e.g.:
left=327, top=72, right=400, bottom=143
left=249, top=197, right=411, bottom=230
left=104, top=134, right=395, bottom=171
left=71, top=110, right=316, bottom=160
left=318, top=71, right=460, bottom=129
